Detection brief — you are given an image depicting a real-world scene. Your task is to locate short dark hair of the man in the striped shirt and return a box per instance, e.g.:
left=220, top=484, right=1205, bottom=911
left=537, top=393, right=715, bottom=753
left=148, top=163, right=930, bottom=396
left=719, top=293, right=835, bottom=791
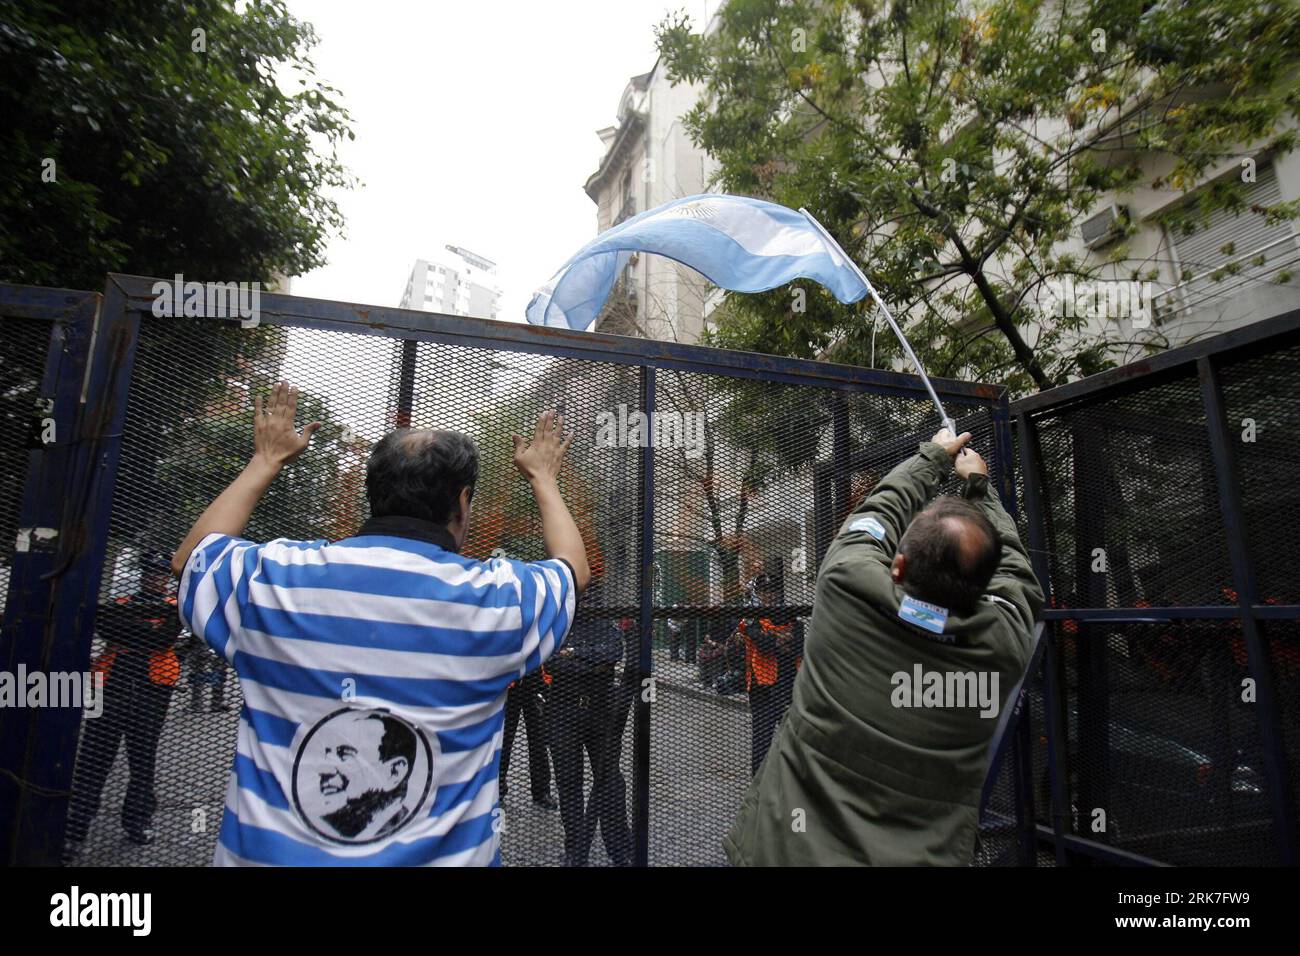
left=365, top=428, right=478, bottom=524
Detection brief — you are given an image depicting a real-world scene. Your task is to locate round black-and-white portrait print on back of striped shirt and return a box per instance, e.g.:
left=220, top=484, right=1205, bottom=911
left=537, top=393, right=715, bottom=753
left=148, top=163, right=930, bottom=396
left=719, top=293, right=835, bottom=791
left=294, top=708, right=437, bottom=844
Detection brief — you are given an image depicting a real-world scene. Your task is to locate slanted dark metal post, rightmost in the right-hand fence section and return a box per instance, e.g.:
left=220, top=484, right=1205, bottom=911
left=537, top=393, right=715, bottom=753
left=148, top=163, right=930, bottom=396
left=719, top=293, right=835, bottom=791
left=1196, top=356, right=1297, bottom=866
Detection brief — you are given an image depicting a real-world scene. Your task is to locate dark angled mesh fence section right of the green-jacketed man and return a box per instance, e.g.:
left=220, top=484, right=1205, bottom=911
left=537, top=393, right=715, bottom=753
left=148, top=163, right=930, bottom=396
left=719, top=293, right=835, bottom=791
left=1022, top=320, right=1300, bottom=865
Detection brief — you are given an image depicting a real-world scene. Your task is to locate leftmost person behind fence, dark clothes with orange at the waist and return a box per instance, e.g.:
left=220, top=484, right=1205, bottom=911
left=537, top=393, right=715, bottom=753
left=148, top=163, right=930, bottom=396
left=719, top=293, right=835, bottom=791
left=65, top=551, right=181, bottom=861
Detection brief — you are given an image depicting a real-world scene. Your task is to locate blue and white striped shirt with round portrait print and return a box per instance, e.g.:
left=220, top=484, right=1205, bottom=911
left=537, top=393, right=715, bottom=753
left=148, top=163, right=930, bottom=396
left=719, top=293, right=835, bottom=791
left=179, top=533, right=576, bottom=866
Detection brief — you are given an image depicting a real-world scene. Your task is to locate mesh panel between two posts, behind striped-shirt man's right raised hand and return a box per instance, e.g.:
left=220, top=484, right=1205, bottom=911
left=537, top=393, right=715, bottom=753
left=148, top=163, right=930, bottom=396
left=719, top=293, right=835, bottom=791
left=423, top=343, right=642, bottom=865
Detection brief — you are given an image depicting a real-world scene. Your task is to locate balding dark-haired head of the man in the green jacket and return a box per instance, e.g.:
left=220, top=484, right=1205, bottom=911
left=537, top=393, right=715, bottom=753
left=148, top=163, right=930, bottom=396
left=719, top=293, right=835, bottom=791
left=898, top=497, right=1002, bottom=613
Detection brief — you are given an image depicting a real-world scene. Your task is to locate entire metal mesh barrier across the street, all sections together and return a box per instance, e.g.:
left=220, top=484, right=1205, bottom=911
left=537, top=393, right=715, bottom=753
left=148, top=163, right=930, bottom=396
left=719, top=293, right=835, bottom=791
left=10, top=276, right=1300, bottom=865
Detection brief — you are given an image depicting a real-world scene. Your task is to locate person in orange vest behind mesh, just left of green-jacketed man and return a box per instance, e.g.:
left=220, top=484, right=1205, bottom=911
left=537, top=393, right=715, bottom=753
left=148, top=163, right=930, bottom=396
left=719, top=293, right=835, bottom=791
left=736, top=574, right=803, bottom=774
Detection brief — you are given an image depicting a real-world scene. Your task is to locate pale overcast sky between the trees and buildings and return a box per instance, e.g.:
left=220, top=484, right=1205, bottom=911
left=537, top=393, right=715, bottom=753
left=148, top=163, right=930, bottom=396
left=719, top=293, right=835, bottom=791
left=289, top=0, right=716, bottom=321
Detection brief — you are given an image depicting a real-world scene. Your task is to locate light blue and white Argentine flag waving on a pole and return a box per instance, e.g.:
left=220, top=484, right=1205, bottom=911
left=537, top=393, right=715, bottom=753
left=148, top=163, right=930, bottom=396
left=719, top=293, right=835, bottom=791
left=527, top=194, right=868, bottom=332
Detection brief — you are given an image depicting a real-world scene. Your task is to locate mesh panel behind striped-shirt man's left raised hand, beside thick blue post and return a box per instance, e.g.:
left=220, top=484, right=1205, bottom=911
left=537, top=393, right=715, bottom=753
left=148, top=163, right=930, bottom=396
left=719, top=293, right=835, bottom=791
left=59, top=316, right=399, bottom=865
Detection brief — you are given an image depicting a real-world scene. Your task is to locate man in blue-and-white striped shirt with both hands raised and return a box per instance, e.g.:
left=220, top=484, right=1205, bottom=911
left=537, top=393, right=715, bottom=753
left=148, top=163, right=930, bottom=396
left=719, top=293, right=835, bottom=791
left=172, top=382, right=589, bottom=866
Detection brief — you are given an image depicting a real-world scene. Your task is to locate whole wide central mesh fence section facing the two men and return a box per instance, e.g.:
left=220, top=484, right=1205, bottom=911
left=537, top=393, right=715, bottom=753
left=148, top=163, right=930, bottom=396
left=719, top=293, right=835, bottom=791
left=15, top=277, right=1004, bottom=865
